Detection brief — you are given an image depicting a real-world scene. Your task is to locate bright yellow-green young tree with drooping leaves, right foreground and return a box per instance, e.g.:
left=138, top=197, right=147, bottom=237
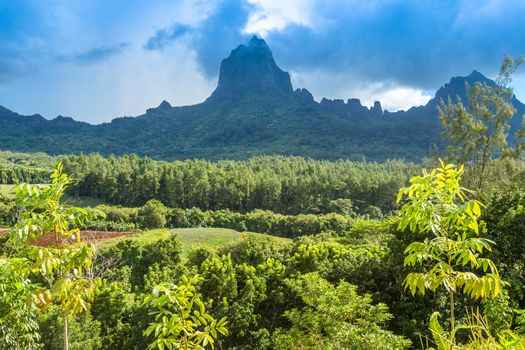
left=397, top=162, right=503, bottom=334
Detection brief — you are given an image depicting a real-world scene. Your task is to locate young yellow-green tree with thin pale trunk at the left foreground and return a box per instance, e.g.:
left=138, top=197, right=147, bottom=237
left=7, top=163, right=103, bottom=350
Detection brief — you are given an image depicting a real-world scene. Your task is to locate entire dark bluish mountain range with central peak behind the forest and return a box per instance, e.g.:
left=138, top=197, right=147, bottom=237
left=0, top=37, right=525, bottom=160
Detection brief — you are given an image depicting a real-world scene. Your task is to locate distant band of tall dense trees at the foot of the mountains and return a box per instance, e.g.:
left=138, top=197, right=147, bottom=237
left=59, top=154, right=417, bottom=214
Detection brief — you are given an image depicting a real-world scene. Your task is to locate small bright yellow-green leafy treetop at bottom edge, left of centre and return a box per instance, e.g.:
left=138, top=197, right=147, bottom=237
left=144, top=276, right=228, bottom=350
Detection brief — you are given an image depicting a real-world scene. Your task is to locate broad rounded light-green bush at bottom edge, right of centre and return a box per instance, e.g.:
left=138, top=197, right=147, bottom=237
left=273, top=274, right=410, bottom=350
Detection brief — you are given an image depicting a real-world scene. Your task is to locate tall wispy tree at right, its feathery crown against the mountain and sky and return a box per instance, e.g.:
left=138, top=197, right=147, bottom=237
left=439, top=56, right=524, bottom=190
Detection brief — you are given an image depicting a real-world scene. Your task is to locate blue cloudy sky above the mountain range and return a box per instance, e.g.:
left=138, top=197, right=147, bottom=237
left=0, top=0, right=525, bottom=123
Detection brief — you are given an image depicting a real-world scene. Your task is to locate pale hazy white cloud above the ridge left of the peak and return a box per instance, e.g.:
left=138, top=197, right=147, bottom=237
left=0, top=45, right=215, bottom=123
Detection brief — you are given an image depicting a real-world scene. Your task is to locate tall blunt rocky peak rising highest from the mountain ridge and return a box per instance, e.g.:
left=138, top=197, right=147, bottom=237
left=208, top=36, right=293, bottom=100
